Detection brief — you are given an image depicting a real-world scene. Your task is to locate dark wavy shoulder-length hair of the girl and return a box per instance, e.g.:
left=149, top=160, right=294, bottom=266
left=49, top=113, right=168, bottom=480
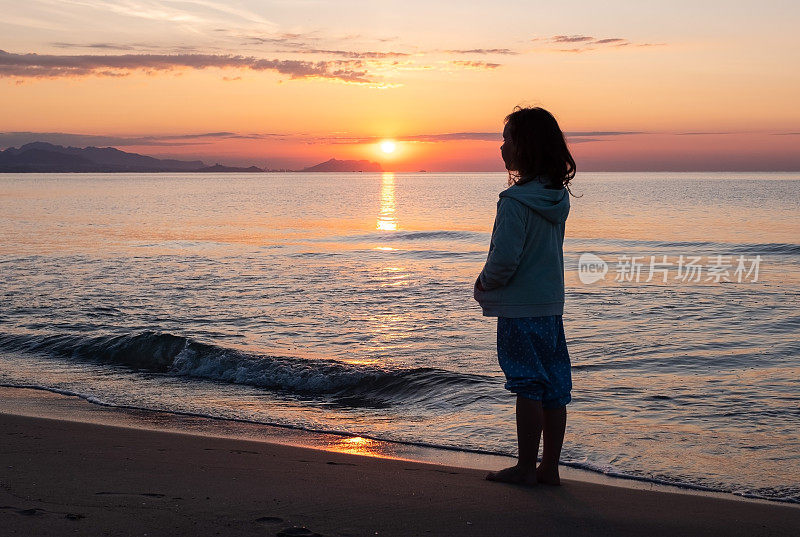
left=505, top=106, right=575, bottom=193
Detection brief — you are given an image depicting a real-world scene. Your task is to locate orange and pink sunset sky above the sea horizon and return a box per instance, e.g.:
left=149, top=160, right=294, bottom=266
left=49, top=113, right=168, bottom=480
left=0, top=0, right=800, bottom=172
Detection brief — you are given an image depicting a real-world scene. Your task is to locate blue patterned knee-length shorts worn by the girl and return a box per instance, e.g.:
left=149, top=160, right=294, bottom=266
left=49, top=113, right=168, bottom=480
left=497, top=315, right=572, bottom=408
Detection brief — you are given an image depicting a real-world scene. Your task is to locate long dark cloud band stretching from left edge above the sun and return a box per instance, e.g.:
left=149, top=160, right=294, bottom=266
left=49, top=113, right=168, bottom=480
left=0, top=50, right=375, bottom=84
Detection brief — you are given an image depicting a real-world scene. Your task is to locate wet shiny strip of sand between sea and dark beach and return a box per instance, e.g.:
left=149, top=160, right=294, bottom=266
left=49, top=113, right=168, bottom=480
left=0, top=385, right=800, bottom=506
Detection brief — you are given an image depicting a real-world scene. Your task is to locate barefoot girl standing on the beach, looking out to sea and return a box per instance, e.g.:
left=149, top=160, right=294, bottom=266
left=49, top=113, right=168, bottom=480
left=474, top=107, right=575, bottom=485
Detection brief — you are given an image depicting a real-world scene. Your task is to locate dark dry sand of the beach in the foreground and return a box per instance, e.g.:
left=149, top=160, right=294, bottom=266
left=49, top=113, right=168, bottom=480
left=0, top=414, right=800, bottom=537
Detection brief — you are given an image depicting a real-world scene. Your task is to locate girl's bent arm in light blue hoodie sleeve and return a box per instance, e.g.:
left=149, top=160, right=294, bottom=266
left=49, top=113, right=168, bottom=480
left=478, top=197, right=528, bottom=291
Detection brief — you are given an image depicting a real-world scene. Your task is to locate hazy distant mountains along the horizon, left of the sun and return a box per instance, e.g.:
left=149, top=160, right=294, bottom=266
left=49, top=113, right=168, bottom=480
left=0, top=142, right=382, bottom=173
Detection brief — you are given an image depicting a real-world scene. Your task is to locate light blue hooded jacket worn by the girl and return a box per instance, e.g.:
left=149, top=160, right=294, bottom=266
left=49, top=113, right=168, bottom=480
left=474, top=179, right=569, bottom=317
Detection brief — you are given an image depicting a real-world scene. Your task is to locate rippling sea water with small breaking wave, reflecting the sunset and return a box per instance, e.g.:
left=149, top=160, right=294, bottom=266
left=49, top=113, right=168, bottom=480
left=0, top=173, right=800, bottom=502
